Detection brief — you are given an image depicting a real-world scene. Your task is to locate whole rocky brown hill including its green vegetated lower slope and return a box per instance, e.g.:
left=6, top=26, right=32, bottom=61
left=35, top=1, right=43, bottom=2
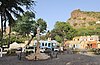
left=67, top=9, right=100, bottom=36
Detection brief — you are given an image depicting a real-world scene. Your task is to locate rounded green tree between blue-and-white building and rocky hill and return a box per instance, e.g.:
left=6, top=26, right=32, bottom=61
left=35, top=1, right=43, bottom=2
left=51, top=21, right=76, bottom=42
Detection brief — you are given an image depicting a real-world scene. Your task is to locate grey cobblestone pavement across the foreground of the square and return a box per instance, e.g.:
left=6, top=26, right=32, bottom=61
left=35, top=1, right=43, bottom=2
left=0, top=54, right=100, bottom=65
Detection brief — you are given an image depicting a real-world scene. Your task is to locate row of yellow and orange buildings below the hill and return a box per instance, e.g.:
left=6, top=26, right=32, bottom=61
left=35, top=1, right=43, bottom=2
left=65, top=35, right=100, bottom=49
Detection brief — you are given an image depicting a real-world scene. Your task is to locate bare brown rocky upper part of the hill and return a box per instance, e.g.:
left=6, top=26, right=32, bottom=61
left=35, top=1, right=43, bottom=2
left=67, top=9, right=100, bottom=28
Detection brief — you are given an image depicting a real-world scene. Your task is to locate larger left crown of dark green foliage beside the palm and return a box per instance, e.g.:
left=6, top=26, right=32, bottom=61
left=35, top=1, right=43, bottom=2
left=13, top=11, right=36, bottom=36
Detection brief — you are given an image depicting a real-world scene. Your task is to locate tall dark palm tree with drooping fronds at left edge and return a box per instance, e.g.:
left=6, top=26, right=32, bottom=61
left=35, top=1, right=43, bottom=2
left=0, top=0, right=35, bottom=47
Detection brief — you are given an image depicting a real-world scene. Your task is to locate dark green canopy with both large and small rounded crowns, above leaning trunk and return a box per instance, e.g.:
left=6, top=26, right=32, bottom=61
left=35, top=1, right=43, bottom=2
left=13, top=11, right=47, bottom=36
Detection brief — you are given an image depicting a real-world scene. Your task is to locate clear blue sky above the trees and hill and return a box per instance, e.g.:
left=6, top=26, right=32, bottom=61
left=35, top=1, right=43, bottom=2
left=34, top=0, right=100, bottom=30
